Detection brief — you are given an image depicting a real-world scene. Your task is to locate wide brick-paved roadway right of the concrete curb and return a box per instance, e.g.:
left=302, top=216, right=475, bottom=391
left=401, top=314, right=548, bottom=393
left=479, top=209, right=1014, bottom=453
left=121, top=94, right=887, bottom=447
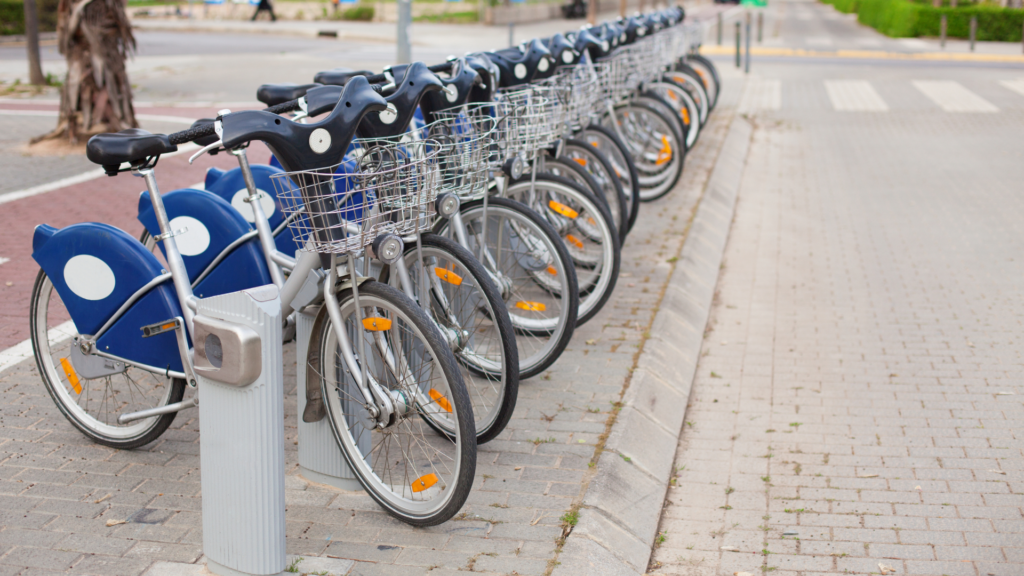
left=651, top=66, right=1024, bottom=576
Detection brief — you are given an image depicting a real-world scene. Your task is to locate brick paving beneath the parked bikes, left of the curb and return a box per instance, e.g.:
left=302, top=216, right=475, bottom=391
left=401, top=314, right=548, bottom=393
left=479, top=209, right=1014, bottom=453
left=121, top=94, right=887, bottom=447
left=0, top=70, right=735, bottom=576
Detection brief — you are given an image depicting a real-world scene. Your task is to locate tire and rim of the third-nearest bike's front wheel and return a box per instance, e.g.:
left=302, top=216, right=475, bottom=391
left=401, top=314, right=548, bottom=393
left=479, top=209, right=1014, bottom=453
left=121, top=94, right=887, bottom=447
left=434, top=197, right=580, bottom=382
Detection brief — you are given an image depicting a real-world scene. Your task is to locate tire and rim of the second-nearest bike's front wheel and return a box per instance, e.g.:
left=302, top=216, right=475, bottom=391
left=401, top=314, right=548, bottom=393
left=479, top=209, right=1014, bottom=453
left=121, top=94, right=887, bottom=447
left=380, top=233, right=519, bottom=444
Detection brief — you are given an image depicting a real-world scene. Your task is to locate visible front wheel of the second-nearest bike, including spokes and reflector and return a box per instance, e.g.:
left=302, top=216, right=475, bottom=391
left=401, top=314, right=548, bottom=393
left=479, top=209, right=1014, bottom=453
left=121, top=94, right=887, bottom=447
left=380, top=234, right=519, bottom=444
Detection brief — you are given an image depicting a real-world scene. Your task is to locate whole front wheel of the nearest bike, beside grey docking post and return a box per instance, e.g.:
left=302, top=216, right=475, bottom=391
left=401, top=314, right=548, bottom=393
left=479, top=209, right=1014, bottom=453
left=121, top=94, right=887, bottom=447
left=317, top=280, right=476, bottom=527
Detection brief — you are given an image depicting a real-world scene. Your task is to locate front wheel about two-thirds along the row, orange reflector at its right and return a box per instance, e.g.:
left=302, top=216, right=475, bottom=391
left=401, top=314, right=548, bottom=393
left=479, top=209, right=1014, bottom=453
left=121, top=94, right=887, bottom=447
left=603, top=102, right=686, bottom=202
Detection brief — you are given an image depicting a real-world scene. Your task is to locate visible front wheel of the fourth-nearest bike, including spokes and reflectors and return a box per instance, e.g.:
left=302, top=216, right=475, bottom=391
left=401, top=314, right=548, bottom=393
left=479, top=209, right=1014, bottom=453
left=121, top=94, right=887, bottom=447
left=506, top=174, right=622, bottom=325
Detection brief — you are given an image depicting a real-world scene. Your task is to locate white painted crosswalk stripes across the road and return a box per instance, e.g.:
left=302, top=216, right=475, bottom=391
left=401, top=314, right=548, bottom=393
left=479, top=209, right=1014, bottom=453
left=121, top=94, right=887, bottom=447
left=738, top=76, right=1024, bottom=114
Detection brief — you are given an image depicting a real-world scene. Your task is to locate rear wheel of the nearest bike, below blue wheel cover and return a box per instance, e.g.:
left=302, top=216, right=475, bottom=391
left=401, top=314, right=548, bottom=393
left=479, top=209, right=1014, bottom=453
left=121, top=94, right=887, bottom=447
left=29, top=271, right=185, bottom=450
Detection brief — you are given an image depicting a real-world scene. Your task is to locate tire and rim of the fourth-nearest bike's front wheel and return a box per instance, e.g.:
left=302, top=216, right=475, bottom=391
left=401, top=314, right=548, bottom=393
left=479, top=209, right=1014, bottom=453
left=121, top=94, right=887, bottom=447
left=506, top=174, right=622, bottom=326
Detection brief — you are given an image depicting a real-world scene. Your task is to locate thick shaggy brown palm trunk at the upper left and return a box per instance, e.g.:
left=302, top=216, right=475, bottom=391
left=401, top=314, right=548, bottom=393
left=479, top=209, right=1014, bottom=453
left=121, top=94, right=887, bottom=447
left=33, top=0, right=138, bottom=143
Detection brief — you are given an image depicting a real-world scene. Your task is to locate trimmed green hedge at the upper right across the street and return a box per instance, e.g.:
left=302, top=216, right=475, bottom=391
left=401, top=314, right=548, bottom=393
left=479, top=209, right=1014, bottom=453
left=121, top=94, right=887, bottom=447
left=822, top=0, right=1024, bottom=42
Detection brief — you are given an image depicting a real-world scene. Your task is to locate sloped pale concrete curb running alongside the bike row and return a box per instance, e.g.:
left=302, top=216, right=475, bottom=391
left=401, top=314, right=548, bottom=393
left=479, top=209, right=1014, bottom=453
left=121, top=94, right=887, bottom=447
left=553, top=116, right=753, bottom=576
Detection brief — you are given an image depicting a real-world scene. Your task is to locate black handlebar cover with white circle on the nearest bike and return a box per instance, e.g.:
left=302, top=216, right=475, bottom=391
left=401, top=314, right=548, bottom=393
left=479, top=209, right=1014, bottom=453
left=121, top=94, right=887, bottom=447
left=221, top=78, right=387, bottom=172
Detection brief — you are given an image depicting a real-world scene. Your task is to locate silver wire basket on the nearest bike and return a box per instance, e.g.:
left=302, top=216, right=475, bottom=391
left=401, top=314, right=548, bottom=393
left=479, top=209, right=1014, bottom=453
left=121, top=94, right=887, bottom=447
left=270, top=138, right=440, bottom=254
